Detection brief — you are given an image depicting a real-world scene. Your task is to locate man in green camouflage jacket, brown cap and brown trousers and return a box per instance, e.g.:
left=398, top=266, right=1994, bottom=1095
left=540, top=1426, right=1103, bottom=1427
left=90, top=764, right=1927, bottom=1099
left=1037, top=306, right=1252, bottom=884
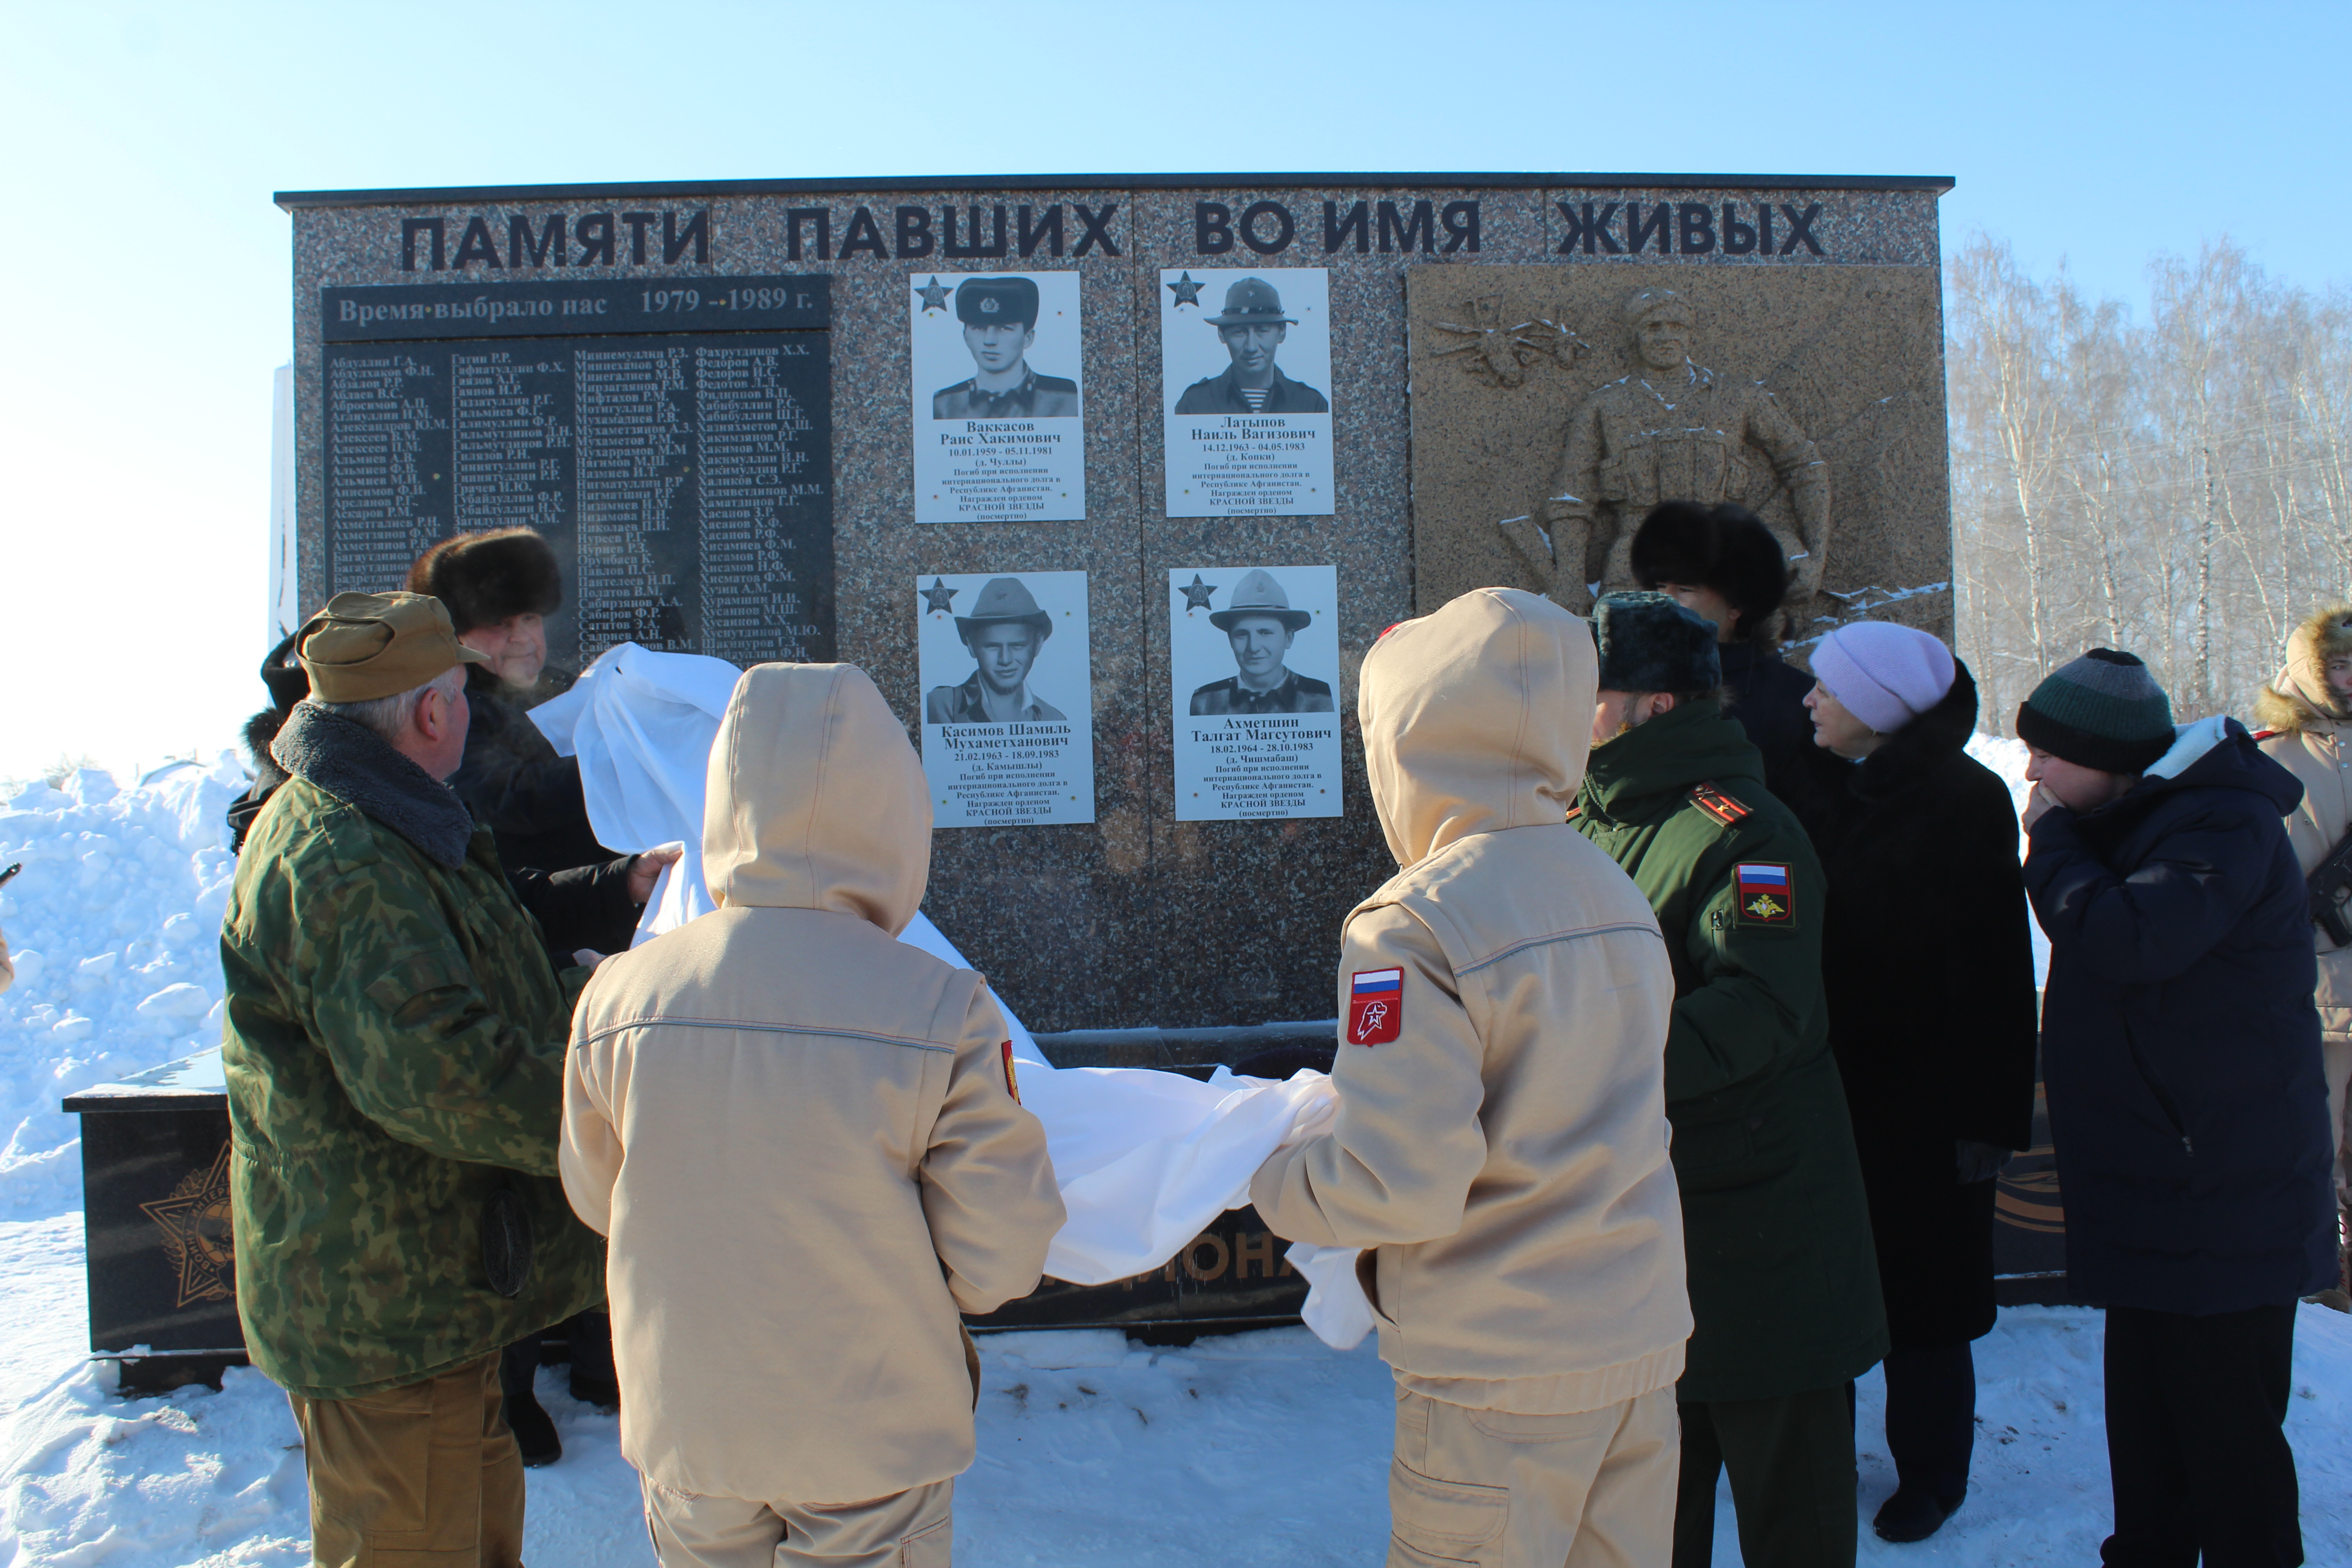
left=221, top=595, right=604, bottom=1568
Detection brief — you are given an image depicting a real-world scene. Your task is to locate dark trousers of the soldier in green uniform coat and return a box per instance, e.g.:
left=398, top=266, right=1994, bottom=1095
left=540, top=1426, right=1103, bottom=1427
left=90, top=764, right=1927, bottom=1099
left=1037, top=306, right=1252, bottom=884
left=1675, top=1382, right=1861, bottom=1568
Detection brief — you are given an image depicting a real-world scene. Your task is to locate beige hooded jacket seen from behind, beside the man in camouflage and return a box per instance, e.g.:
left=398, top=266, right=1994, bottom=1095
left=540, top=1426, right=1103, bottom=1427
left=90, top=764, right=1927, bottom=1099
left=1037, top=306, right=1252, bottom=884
left=562, top=665, right=1063, bottom=1502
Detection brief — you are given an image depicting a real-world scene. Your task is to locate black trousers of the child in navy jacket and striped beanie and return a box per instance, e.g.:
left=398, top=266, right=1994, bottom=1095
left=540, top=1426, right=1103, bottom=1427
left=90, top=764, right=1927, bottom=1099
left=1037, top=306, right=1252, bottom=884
left=2098, top=1303, right=2303, bottom=1568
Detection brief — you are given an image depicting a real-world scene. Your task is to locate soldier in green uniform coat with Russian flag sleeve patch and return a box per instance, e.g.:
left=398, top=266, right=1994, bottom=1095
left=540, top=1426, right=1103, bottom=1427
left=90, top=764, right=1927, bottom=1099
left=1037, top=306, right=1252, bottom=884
left=1573, top=593, right=1886, bottom=1568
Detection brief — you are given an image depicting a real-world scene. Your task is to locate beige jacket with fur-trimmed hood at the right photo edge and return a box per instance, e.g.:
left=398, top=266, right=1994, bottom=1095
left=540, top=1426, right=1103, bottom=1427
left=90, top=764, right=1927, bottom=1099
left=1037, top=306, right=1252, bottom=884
left=2253, top=604, right=2352, bottom=1037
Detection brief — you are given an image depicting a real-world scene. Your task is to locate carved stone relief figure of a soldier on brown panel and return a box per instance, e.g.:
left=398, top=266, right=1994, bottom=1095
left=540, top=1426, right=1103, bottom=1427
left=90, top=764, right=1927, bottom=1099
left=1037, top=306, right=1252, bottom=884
left=1505, top=287, right=1830, bottom=611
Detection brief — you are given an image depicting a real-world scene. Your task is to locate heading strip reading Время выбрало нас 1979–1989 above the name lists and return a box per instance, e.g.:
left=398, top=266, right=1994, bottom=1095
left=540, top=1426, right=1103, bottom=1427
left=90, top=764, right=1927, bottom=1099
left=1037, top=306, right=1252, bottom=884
left=320, top=273, right=833, bottom=343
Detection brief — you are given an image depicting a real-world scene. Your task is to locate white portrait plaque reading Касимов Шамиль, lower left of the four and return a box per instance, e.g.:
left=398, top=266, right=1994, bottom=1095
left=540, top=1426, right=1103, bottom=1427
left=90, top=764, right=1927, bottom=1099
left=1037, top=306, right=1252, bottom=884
left=915, top=571, right=1094, bottom=828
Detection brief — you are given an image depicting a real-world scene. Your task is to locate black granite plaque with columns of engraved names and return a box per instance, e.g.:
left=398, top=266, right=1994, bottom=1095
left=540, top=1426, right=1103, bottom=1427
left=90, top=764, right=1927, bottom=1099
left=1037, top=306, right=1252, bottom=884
left=322, top=277, right=835, bottom=668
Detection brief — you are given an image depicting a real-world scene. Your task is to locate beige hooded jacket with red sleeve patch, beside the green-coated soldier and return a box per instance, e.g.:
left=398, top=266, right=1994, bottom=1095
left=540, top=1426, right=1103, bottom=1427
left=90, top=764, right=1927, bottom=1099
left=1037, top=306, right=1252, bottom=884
left=1249, top=588, right=1691, bottom=1415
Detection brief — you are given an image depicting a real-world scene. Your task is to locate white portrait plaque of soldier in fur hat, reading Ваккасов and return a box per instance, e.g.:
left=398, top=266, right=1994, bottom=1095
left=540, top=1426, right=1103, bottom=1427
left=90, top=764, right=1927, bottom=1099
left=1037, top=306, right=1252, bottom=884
left=908, top=273, right=1087, bottom=522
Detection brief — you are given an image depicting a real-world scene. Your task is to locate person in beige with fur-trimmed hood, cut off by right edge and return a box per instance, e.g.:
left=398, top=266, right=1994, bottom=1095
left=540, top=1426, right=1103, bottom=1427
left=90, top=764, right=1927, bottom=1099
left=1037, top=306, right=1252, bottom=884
left=2253, top=604, right=2352, bottom=1312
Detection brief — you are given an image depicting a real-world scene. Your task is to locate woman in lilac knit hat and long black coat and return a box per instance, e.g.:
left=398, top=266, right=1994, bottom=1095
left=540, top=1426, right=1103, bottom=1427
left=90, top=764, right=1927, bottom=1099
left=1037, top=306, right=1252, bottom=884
left=1792, top=623, right=2034, bottom=1540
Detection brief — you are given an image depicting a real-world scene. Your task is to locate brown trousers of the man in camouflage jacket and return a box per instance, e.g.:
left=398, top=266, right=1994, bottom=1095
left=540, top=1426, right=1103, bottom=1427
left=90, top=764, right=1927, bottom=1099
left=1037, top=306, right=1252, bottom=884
left=287, top=1357, right=522, bottom=1568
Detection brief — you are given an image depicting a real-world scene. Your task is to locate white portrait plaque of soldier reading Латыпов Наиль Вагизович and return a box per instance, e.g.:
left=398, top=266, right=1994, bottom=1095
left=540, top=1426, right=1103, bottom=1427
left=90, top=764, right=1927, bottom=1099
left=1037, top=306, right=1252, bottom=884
left=1160, top=268, right=1331, bottom=517
